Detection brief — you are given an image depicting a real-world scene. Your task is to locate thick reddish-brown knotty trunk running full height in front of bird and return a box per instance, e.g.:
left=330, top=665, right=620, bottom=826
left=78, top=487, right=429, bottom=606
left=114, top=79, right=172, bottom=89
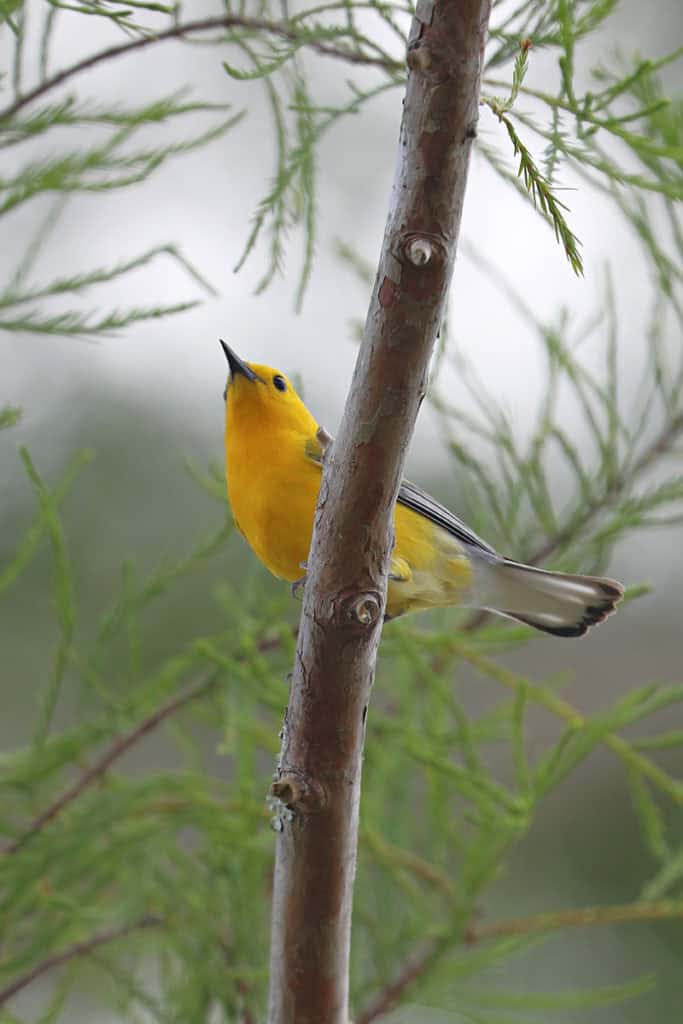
left=268, top=0, right=490, bottom=1024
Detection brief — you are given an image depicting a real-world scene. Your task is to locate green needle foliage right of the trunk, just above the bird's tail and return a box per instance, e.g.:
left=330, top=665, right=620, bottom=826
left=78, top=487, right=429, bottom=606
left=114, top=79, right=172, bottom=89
left=431, top=242, right=683, bottom=571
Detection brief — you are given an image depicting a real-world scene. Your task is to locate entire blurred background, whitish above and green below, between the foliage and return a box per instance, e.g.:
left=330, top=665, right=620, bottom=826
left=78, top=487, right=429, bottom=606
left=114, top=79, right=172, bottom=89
left=0, top=0, right=683, bottom=1024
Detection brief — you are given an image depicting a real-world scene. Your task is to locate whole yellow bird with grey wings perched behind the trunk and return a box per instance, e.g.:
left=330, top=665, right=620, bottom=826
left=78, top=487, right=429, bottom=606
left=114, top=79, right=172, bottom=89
left=221, top=341, right=624, bottom=637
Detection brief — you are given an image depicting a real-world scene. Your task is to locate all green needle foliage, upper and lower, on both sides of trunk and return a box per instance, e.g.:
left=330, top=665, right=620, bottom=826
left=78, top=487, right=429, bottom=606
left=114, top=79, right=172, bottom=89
left=0, top=0, right=683, bottom=1024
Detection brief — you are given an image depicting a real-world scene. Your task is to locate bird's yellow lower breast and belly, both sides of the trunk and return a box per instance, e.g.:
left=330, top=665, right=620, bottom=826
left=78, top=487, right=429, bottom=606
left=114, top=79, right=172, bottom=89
left=227, top=436, right=471, bottom=617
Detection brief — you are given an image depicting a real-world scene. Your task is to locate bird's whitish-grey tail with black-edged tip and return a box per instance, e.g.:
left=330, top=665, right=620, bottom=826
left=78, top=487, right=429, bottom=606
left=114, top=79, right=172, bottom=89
left=480, top=558, right=624, bottom=637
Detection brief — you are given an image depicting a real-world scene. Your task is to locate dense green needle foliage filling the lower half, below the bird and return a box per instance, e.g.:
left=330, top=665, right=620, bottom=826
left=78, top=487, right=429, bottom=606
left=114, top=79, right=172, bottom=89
left=0, top=436, right=683, bottom=1021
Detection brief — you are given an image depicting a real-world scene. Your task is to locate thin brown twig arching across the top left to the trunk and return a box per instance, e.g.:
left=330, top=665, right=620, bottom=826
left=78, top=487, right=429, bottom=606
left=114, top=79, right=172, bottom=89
left=0, top=14, right=403, bottom=122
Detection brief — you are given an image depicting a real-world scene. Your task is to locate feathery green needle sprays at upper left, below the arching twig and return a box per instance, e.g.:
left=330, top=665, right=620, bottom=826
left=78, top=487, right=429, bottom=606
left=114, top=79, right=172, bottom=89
left=0, top=80, right=244, bottom=338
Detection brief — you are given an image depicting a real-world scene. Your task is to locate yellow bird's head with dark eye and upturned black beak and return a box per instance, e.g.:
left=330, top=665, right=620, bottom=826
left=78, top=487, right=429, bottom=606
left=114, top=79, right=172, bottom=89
left=220, top=340, right=317, bottom=434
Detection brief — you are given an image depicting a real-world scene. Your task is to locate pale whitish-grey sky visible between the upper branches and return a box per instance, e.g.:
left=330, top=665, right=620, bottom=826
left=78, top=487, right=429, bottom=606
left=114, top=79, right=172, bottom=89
left=0, top=2, right=680, bottom=598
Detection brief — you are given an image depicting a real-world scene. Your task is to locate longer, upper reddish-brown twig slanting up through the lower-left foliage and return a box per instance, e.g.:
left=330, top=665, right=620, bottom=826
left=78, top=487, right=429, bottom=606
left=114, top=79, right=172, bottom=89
left=0, top=676, right=218, bottom=855
